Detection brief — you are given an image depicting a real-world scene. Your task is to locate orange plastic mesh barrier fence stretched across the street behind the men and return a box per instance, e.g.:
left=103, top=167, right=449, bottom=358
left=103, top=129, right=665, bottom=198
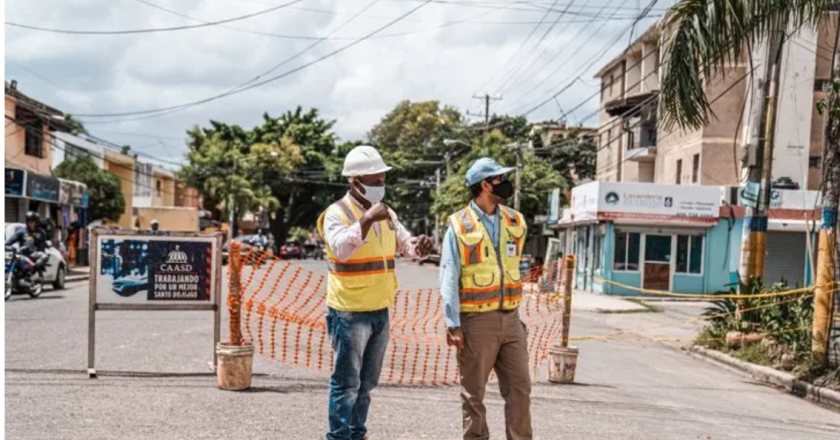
left=231, top=252, right=562, bottom=386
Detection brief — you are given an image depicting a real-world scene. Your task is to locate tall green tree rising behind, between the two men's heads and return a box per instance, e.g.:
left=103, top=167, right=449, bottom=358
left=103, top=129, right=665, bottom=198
left=368, top=100, right=467, bottom=231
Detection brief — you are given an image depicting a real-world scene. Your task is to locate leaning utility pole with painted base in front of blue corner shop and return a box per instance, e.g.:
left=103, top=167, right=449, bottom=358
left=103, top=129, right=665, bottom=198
left=738, top=29, right=785, bottom=286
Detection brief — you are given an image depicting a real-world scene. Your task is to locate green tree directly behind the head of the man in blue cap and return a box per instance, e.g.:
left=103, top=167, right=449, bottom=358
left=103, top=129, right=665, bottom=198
left=434, top=131, right=568, bottom=222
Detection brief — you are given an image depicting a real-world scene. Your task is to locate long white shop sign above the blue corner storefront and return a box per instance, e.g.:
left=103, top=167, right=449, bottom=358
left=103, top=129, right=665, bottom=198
left=572, top=182, right=720, bottom=222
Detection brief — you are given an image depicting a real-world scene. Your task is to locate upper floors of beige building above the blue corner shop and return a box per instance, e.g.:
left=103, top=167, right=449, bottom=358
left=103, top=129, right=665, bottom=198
left=596, top=18, right=834, bottom=189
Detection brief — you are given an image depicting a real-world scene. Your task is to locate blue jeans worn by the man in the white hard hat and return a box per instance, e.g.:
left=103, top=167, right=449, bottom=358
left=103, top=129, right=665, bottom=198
left=327, top=308, right=390, bottom=440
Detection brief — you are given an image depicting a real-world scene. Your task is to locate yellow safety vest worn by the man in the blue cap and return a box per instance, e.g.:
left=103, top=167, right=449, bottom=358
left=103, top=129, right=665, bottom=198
left=449, top=205, right=527, bottom=313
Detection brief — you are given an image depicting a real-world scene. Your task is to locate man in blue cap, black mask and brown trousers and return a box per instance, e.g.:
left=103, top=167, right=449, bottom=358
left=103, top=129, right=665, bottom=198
left=440, top=157, right=533, bottom=440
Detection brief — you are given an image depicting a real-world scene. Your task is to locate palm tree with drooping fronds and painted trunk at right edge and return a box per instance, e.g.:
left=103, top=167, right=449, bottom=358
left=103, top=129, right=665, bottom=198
left=659, top=0, right=840, bottom=359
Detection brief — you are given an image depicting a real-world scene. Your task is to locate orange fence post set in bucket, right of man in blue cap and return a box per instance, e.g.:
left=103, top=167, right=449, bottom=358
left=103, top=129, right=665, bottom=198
left=548, top=255, right=578, bottom=383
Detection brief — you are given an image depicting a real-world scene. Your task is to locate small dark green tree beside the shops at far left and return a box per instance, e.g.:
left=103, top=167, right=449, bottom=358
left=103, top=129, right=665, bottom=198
left=53, top=155, right=125, bottom=221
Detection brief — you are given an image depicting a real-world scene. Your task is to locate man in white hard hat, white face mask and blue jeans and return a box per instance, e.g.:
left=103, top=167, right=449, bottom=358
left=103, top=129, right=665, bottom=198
left=318, top=145, right=432, bottom=440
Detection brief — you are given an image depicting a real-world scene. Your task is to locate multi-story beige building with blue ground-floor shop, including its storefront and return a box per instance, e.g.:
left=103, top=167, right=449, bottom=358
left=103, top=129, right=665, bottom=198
left=559, top=18, right=837, bottom=294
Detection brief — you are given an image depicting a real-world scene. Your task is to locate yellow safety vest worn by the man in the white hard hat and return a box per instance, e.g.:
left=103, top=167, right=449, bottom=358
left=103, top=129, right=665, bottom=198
left=318, top=195, right=397, bottom=312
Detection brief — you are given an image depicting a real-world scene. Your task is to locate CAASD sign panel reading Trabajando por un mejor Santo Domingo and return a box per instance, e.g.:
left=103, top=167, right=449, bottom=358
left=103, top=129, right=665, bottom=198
left=95, top=236, right=216, bottom=303
